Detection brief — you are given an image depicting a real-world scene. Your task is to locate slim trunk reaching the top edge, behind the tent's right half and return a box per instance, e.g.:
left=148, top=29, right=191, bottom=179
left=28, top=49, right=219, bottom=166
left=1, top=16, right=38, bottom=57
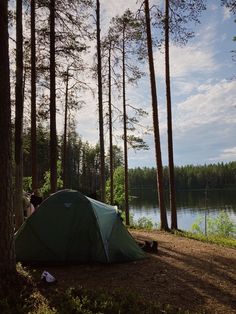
left=96, top=0, right=105, bottom=202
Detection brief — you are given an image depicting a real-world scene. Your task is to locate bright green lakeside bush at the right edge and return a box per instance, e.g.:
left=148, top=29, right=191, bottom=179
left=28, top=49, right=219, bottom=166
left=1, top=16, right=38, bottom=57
left=191, top=211, right=236, bottom=238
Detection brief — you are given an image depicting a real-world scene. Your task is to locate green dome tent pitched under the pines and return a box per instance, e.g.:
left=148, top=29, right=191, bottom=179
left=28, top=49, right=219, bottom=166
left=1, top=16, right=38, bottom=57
left=15, top=190, right=144, bottom=263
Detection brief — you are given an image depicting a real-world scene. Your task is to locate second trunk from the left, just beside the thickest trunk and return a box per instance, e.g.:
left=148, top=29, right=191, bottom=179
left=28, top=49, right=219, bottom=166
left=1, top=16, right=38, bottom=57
left=14, top=0, right=24, bottom=229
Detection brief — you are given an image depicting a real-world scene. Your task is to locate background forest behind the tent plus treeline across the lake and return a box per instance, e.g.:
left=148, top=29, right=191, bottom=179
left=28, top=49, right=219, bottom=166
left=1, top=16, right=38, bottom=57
left=23, top=125, right=236, bottom=195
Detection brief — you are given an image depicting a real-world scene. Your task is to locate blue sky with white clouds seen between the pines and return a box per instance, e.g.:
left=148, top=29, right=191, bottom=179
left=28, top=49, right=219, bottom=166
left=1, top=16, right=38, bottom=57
left=74, top=0, right=236, bottom=168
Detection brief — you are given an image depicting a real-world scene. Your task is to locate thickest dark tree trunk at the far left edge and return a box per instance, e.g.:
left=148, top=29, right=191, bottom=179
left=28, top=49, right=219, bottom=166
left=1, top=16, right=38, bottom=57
left=0, top=0, right=16, bottom=282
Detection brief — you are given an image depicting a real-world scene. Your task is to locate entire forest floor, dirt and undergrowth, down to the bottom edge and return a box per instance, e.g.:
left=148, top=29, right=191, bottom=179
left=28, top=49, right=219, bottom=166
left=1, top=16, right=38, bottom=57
left=0, top=230, right=236, bottom=314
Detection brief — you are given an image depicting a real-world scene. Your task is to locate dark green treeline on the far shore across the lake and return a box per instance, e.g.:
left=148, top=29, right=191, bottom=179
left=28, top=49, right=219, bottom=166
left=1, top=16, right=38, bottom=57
left=129, top=162, right=236, bottom=190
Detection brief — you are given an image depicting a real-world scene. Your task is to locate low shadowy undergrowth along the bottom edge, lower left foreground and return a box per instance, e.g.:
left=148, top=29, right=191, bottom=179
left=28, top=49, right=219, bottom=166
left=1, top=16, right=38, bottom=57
left=0, top=264, right=194, bottom=314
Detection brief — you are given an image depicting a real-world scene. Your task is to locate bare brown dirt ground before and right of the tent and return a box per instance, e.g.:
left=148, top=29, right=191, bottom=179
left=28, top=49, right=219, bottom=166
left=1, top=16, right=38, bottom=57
left=34, top=231, right=236, bottom=314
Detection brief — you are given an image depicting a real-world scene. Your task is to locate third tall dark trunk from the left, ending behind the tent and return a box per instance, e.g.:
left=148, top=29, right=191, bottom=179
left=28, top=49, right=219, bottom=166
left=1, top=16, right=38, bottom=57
left=31, top=0, right=38, bottom=190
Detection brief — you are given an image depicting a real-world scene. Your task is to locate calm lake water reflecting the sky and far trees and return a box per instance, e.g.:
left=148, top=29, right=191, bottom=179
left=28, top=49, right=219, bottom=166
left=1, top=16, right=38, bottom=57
left=130, top=190, right=236, bottom=230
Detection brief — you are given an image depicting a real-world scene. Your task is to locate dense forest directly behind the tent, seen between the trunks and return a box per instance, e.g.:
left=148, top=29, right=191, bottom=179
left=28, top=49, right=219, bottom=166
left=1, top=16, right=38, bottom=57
left=23, top=124, right=123, bottom=195
